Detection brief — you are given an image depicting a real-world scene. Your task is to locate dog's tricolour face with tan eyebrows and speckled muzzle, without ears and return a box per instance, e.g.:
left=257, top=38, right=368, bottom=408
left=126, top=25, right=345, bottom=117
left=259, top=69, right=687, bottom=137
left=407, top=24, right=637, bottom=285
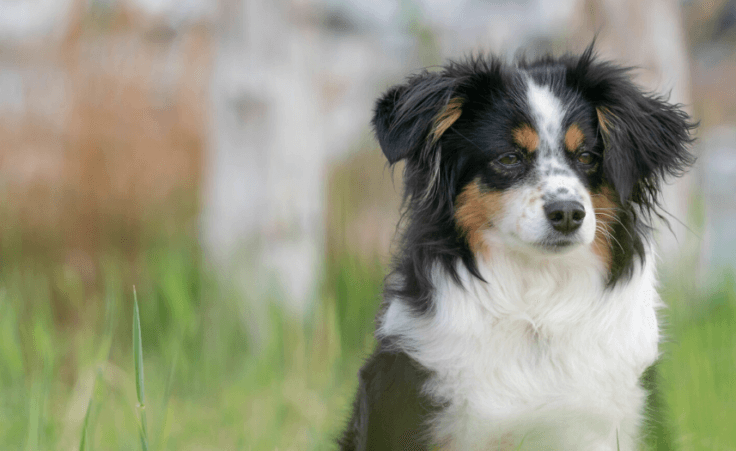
left=452, top=74, right=605, bottom=255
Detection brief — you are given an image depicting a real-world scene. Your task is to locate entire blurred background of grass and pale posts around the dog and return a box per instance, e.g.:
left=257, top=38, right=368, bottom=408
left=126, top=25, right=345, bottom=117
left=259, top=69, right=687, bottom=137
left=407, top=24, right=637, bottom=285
left=0, top=0, right=736, bottom=450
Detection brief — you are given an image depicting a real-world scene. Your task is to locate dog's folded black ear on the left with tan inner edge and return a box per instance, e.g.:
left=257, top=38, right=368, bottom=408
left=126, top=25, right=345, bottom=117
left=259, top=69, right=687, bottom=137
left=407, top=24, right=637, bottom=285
left=373, top=72, right=462, bottom=164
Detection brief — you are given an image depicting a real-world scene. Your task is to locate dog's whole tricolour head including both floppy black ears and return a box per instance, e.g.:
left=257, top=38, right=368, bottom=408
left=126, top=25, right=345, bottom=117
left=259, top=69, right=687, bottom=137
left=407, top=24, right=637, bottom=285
left=373, top=46, right=693, bottom=281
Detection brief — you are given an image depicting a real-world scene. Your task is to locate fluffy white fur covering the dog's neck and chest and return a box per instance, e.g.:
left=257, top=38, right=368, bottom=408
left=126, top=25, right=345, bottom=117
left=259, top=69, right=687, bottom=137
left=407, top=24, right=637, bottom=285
left=378, top=248, right=660, bottom=451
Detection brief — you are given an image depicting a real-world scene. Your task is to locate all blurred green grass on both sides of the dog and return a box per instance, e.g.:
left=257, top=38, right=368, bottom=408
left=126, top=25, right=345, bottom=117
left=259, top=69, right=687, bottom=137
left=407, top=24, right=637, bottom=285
left=0, top=235, right=736, bottom=450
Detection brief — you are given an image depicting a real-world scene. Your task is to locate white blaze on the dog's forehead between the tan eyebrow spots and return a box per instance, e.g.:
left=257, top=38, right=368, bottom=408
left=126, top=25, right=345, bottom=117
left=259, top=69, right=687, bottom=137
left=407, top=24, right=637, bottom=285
left=527, top=77, right=564, bottom=156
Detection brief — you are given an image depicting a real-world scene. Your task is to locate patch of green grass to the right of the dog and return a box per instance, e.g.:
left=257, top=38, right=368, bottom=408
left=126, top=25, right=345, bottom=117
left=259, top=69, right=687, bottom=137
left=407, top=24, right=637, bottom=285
left=661, top=271, right=736, bottom=450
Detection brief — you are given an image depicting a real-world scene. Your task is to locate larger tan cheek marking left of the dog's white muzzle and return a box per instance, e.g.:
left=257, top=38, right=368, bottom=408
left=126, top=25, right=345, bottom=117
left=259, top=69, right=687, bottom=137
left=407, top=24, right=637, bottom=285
left=455, top=180, right=501, bottom=254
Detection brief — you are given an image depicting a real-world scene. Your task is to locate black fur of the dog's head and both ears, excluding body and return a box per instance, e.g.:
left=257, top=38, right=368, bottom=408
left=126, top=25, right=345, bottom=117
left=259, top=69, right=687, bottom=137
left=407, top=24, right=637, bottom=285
left=373, top=45, right=695, bottom=312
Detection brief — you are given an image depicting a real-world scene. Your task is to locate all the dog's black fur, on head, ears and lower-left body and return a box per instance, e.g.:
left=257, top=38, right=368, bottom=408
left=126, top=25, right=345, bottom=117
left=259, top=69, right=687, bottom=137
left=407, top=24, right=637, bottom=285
left=340, top=45, right=694, bottom=450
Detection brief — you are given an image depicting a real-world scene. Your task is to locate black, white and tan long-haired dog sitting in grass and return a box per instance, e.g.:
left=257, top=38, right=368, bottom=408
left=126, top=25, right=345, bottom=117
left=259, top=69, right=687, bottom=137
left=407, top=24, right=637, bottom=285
left=338, top=44, right=695, bottom=451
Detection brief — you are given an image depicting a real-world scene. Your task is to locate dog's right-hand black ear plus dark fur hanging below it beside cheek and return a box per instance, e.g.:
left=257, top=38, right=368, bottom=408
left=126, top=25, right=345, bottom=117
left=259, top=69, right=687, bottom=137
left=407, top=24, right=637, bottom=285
left=566, top=45, right=696, bottom=282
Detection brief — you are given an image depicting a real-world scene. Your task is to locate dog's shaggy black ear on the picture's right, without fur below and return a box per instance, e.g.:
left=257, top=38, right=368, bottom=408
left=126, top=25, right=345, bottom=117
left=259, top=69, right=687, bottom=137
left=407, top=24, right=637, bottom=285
left=569, top=45, right=695, bottom=211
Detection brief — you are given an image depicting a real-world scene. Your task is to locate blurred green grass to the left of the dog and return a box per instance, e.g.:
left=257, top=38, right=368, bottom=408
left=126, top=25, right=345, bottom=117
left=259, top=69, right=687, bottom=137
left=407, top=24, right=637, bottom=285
left=0, top=237, right=374, bottom=450
